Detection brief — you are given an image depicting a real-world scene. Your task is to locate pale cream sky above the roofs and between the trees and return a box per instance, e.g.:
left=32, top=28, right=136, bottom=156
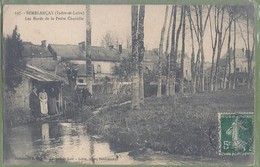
left=3, top=5, right=254, bottom=61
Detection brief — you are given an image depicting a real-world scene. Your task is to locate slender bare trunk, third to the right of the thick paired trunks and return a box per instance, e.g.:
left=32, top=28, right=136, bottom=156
left=169, top=5, right=177, bottom=96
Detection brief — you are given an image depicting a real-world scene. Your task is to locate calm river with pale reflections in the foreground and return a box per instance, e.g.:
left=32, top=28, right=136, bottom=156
left=5, top=122, right=230, bottom=165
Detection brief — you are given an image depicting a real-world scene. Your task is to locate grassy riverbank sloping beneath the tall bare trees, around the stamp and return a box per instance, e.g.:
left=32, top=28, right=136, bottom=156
left=86, top=90, right=254, bottom=162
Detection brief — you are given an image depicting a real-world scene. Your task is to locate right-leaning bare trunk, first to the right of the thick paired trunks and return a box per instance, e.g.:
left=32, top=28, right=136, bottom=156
left=157, top=5, right=168, bottom=97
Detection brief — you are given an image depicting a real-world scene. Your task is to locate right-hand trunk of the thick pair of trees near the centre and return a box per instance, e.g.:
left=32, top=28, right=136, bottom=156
left=138, top=5, right=145, bottom=104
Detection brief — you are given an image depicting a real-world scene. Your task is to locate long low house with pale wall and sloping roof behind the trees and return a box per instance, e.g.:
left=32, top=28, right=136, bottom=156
left=48, top=42, right=158, bottom=86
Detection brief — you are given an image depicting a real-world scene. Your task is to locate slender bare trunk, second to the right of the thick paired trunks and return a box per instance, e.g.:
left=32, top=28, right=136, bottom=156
left=165, top=7, right=174, bottom=96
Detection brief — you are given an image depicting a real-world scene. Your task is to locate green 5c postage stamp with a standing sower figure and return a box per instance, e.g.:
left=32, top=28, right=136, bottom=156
left=218, top=113, right=254, bottom=155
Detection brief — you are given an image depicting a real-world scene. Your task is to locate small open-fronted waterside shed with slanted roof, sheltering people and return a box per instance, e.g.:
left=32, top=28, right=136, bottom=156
left=4, top=65, right=66, bottom=115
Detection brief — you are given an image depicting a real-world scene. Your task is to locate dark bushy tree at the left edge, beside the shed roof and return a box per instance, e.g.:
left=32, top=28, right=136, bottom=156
left=4, top=26, right=26, bottom=91
